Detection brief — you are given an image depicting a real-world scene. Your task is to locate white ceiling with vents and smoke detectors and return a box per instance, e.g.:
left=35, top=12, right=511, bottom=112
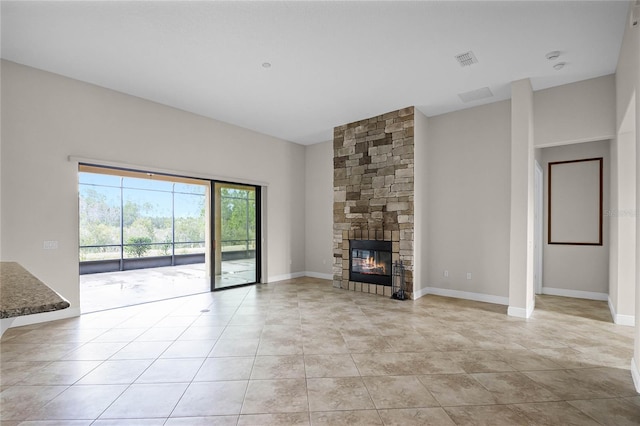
left=1, top=0, right=629, bottom=144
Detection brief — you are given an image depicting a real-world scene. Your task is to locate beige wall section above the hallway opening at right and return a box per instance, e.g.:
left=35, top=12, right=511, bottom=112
left=533, top=75, right=616, bottom=148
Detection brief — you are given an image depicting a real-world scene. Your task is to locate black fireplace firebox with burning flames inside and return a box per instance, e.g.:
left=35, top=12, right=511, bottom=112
left=349, top=240, right=392, bottom=286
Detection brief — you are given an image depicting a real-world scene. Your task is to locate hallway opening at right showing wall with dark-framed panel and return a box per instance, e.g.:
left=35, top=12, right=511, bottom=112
left=536, top=140, right=612, bottom=322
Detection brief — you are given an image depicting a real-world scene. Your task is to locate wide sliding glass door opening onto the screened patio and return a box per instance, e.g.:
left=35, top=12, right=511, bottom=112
left=78, top=164, right=260, bottom=312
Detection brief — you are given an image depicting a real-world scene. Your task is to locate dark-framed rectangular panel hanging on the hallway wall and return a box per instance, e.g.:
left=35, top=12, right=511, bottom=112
left=548, top=157, right=603, bottom=246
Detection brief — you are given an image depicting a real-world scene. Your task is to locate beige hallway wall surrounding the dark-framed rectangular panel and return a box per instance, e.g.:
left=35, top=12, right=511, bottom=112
left=541, top=141, right=610, bottom=300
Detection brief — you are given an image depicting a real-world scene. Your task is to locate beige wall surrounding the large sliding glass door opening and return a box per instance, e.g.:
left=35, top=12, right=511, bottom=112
left=1, top=61, right=305, bottom=307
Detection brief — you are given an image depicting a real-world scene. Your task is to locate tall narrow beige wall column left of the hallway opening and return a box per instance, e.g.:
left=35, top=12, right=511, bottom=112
left=507, top=79, right=535, bottom=318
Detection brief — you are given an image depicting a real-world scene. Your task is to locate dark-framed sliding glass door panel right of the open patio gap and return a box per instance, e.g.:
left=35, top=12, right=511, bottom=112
left=211, top=182, right=260, bottom=289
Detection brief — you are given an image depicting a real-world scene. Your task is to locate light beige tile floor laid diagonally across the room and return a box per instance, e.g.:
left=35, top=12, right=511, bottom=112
left=0, top=278, right=640, bottom=426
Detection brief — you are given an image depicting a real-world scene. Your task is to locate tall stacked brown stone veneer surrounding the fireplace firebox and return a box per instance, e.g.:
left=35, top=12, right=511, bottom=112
left=333, top=107, right=414, bottom=295
